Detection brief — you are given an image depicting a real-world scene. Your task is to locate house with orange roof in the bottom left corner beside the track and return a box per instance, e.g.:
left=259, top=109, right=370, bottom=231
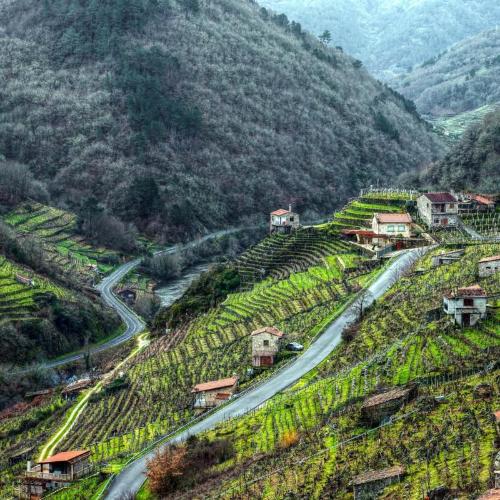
left=21, top=450, right=92, bottom=500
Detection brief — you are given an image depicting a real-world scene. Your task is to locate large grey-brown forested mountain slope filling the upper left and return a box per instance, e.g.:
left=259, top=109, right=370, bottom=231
left=0, top=0, right=442, bottom=239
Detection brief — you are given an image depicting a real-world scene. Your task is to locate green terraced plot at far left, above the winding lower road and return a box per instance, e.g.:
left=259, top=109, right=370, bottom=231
left=4, top=203, right=118, bottom=280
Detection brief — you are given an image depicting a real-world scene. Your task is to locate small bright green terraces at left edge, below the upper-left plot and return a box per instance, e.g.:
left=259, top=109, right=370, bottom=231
left=0, top=256, right=68, bottom=322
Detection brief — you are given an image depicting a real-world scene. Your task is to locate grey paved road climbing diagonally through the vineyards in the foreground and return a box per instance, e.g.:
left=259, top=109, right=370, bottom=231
left=106, top=249, right=422, bottom=500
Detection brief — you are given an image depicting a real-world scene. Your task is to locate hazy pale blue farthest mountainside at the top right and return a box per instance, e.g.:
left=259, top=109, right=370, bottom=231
left=260, top=0, right=500, bottom=79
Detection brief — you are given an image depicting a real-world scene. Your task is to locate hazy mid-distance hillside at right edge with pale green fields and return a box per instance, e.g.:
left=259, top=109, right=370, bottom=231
left=393, top=29, right=500, bottom=118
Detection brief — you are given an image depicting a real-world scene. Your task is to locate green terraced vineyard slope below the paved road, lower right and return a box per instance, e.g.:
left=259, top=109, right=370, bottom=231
left=146, top=245, right=500, bottom=498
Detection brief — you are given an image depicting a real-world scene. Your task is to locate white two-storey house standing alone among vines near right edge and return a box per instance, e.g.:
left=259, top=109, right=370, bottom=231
left=443, top=285, right=488, bottom=326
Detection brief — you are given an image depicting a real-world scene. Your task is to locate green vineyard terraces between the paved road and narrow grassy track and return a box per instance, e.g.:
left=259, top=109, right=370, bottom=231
left=49, top=232, right=378, bottom=461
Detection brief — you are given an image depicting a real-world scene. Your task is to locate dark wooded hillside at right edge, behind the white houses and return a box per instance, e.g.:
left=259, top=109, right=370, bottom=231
left=421, top=111, right=500, bottom=193
